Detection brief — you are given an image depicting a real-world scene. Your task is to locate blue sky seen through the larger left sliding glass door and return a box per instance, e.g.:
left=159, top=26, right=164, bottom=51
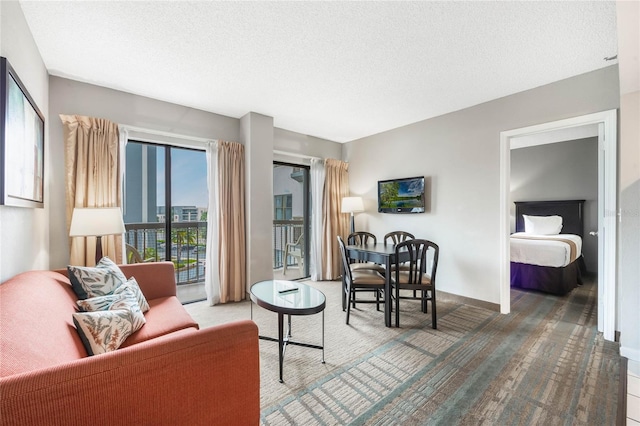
left=156, top=148, right=208, bottom=207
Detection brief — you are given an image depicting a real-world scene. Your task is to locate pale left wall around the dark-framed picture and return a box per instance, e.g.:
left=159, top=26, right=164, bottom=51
left=0, top=1, right=52, bottom=282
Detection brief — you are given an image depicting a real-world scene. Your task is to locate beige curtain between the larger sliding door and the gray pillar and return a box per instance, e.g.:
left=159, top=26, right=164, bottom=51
left=217, top=141, right=247, bottom=303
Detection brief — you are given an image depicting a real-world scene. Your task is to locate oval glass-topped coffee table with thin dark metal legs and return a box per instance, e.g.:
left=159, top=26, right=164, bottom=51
left=250, top=280, right=326, bottom=383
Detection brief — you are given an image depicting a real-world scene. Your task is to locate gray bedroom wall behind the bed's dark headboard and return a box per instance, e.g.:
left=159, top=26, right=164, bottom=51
left=511, top=138, right=598, bottom=272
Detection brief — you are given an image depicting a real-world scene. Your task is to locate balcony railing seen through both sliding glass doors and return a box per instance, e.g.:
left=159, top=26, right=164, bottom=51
left=125, top=220, right=304, bottom=285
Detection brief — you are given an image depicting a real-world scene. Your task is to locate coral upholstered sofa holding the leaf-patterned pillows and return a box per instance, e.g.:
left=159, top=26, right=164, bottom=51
left=0, top=262, right=260, bottom=425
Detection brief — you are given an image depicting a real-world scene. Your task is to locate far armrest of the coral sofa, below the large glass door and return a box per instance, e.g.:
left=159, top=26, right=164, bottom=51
left=118, top=262, right=176, bottom=299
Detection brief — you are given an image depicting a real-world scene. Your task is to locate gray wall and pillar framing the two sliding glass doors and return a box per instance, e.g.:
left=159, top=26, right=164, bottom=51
left=49, top=77, right=341, bottom=276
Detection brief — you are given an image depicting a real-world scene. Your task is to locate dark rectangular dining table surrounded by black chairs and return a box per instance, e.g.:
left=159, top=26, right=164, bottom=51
left=342, top=243, right=410, bottom=327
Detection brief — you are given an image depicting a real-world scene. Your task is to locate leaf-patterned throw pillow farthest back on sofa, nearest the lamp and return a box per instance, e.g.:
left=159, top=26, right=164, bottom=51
left=67, top=257, right=127, bottom=299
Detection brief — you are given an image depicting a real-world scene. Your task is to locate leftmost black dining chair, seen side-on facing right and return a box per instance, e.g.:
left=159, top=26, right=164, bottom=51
left=338, top=235, right=385, bottom=324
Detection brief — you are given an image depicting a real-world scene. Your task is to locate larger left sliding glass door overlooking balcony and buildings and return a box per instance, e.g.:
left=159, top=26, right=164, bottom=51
left=124, top=141, right=208, bottom=303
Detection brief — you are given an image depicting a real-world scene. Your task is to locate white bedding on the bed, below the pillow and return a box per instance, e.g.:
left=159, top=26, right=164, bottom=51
left=510, top=232, right=582, bottom=268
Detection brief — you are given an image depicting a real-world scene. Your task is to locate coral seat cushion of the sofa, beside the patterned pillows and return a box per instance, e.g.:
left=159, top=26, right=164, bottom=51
left=121, top=296, right=199, bottom=348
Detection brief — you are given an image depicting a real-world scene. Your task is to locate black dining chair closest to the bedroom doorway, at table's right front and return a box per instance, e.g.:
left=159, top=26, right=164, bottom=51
left=391, top=239, right=440, bottom=329
